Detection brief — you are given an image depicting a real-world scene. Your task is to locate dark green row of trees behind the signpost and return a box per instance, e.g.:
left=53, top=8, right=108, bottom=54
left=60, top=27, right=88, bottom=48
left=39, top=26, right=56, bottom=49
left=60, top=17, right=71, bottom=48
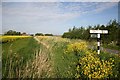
left=62, top=20, right=120, bottom=45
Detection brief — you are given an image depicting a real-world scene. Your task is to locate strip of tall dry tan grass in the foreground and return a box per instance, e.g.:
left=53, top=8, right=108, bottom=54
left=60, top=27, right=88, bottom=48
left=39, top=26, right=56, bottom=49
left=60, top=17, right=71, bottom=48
left=23, top=39, right=53, bottom=78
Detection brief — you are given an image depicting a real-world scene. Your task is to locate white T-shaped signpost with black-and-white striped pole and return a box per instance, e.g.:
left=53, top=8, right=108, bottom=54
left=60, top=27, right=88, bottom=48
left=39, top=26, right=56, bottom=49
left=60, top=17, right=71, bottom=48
left=90, top=30, right=108, bottom=54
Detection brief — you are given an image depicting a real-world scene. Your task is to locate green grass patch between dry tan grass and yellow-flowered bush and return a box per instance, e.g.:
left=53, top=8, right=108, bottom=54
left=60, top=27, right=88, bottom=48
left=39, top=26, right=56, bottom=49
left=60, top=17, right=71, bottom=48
left=53, top=42, right=76, bottom=78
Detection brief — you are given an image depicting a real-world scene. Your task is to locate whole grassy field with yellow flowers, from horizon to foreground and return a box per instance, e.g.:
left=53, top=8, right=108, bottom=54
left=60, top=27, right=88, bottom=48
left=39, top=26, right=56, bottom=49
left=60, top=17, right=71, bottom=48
left=1, top=36, right=120, bottom=79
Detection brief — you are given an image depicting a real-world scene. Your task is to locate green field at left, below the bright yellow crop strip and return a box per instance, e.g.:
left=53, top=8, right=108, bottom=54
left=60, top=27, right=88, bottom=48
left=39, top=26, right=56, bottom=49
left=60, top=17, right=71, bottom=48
left=2, top=38, right=39, bottom=78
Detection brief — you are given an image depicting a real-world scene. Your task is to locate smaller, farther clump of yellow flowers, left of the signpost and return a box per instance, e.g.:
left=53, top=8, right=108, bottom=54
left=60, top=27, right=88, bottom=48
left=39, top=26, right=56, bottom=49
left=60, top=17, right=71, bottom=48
left=65, top=41, right=87, bottom=53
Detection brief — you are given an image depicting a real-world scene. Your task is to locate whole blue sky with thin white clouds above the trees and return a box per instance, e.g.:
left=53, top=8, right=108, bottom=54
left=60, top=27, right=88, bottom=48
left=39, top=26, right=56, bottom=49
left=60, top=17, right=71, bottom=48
left=2, top=2, right=118, bottom=34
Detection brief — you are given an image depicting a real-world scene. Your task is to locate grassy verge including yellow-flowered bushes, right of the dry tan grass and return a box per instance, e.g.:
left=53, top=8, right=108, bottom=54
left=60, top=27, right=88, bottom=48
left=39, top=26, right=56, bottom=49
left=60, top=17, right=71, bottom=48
left=33, top=37, right=120, bottom=79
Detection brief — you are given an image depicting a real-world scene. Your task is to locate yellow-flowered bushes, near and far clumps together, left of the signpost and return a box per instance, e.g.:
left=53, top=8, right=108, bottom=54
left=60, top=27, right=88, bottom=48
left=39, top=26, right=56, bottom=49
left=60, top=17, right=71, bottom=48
left=65, top=41, right=114, bottom=79
